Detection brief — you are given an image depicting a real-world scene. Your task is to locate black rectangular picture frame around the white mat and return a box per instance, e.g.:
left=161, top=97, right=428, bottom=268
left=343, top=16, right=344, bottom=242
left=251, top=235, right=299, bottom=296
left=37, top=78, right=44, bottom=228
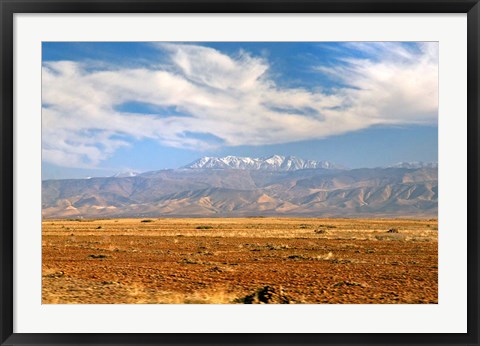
left=0, top=0, right=480, bottom=345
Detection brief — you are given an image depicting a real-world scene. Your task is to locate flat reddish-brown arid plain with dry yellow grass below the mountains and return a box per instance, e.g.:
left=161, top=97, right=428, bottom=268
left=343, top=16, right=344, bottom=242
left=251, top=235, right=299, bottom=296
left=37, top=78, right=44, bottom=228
left=42, top=217, right=438, bottom=304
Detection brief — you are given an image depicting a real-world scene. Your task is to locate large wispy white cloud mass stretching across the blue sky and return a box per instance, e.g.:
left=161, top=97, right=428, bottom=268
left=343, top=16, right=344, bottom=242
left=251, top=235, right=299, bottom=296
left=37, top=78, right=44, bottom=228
left=42, top=43, right=438, bottom=167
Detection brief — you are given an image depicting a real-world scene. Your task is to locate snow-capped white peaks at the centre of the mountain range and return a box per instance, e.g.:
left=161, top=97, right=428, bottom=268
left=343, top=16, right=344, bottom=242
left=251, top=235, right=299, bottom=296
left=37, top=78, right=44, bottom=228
left=183, top=155, right=345, bottom=171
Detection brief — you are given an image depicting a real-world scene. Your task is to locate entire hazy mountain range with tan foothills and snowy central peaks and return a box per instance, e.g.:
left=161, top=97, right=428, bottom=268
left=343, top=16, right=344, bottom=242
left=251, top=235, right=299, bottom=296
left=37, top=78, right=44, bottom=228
left=42, top=155, right=438, bottom=218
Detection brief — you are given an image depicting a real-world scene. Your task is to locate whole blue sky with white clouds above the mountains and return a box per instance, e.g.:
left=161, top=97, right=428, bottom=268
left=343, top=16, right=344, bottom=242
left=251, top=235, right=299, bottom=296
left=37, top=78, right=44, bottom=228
left=42, top=42, right=438, bottom=179
